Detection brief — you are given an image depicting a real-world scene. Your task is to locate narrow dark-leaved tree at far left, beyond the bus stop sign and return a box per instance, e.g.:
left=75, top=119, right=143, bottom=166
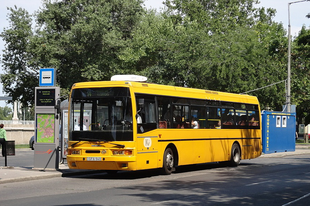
left=0, top=7, right=38, bottom=105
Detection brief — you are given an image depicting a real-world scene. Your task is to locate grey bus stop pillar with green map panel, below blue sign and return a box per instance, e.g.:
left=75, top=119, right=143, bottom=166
left=34, top=87, right=60, bottom=170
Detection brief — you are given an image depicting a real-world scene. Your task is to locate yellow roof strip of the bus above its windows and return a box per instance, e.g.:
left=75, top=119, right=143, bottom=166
left=72, top=81, right=258, bottom=104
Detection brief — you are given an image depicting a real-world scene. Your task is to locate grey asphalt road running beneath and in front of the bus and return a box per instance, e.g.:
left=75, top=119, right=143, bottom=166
left=0, top=151, right=310, bottom=206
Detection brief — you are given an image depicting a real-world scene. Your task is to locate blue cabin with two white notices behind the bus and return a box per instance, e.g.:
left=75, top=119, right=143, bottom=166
left=261, top=111, right=296, bottom=154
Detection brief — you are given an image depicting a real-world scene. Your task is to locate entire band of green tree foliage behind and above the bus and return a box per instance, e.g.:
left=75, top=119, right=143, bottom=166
left=1, top=0, right=309, bottom=120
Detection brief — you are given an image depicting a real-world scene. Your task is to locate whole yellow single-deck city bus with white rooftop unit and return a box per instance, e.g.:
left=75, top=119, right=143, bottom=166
left=67, top=76, right=262, bottom=174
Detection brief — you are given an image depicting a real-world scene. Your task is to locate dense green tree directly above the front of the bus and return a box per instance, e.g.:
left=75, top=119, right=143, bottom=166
left=33, top=0, right=143, bottom=89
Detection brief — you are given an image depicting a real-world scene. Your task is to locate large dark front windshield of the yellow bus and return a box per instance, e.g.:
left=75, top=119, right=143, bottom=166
left=69, top=87, right=133, bottom=141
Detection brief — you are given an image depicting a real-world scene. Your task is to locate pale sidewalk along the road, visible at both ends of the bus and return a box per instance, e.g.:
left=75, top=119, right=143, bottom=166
left=0, top=145, right=310, bottom=184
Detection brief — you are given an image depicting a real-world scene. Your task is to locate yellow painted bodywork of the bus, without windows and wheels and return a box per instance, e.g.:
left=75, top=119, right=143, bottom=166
left=67, top=81, right=262, bottom=170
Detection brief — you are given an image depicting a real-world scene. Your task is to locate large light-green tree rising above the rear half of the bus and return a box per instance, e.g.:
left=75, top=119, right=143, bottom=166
left=122, top=0, right=287, bottom=110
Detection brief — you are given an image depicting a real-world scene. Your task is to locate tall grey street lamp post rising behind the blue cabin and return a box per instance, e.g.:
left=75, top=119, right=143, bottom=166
left=286, top=0, right=310, bottom=112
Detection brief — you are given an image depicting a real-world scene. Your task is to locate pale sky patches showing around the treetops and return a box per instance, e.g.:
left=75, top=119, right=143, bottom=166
left=0, top=0, right=310, bottom=108
